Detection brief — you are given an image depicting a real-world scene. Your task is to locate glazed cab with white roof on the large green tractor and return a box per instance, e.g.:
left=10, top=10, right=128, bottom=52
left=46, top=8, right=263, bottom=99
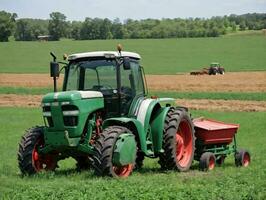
left=63, top=51, right=146, bottom=118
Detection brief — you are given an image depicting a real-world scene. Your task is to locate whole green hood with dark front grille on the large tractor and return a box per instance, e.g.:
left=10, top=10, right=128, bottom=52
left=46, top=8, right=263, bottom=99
left=42, top=91, right=104, bottom=139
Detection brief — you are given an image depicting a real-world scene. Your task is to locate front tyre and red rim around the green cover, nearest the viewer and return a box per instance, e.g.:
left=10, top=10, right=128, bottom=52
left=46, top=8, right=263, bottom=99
left=93, top=126, right=136, bottom=177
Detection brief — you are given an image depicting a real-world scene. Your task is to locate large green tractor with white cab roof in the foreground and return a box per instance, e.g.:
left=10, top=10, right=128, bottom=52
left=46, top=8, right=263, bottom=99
left=18, top=46, right=195, bottom=177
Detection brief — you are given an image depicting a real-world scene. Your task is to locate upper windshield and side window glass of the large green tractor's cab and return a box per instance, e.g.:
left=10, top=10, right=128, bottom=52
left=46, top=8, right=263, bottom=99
left=65, top=59, right=144, bottom=96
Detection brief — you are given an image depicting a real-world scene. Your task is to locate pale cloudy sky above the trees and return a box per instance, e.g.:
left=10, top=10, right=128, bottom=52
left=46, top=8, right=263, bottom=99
left=0, top=0, right=266, bottom=21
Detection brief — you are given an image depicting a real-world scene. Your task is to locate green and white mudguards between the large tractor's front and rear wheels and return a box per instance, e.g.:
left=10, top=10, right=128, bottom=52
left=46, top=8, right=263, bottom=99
left=103, top=98, right=174, bottom=156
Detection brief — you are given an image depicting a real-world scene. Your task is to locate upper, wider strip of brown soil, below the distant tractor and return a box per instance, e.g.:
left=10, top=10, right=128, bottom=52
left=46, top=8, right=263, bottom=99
left=0, top=71, right=266, bottom=92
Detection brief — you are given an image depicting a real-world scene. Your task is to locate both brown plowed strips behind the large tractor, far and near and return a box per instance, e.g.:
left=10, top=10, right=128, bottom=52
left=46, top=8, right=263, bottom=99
left=0, top=72, right=266, bottom=111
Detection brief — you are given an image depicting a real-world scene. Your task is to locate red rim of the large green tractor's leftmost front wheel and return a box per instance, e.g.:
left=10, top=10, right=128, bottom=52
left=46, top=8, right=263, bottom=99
left=32, top=140, right=56, bottom=172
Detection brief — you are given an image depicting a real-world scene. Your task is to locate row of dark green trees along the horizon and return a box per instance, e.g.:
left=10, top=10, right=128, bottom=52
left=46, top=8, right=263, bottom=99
left=0, top=11, right=266, bottom=41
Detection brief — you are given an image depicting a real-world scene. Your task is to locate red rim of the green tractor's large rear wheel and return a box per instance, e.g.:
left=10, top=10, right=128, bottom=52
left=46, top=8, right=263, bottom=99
left=175, top=120, right=193, bottom=167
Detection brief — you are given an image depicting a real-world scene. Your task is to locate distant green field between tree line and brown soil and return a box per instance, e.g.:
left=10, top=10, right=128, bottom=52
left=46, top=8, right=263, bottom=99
left=0, top=34, right=266, bottom=74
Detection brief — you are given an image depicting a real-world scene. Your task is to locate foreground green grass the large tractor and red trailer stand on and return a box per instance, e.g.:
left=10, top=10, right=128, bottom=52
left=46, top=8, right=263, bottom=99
left=0, top=108, right=266, bottom=200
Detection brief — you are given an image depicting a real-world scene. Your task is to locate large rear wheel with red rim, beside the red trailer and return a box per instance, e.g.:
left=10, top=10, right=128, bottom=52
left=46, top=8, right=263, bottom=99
left=159, top=108, right=195, bottom=171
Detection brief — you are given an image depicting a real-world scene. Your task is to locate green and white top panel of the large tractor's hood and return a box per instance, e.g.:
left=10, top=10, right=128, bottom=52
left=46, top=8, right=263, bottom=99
left=42, top=91, right=103, bottom=103
